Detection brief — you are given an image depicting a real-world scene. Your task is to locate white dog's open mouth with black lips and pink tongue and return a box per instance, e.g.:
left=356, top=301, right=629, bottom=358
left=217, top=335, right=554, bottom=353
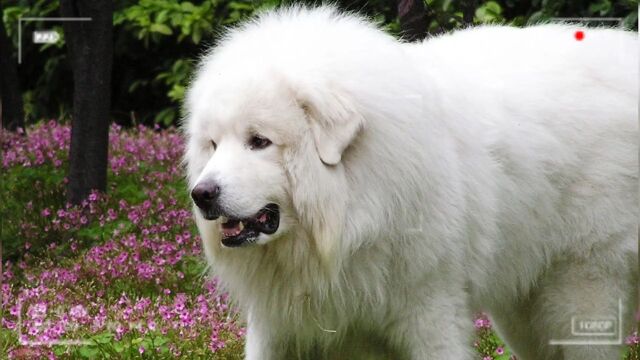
left=220, top=204, right=280, bottom=247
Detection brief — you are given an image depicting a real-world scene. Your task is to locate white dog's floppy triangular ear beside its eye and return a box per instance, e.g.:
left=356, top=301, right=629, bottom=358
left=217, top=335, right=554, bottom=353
left=298, top=90, right=364, bottom=165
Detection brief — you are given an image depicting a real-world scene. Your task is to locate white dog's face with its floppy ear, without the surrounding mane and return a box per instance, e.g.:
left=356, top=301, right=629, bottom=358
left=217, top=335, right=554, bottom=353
left=186, top=50, right=364, bottom=264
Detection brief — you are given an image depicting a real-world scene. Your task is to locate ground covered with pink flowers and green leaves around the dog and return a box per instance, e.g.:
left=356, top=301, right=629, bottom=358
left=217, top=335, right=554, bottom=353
left=0, top=121, right=640, bottom=360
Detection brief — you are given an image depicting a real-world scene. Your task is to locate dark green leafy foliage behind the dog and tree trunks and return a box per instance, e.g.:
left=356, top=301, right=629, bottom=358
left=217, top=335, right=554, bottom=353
left=0, top=0, right=638, bottom=126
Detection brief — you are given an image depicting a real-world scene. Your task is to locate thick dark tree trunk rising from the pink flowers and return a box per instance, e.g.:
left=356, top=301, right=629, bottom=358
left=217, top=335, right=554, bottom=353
left=60, top=0, right=113, bottom=204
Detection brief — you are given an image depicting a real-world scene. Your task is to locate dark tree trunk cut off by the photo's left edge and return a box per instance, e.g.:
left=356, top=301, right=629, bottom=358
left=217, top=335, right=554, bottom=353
left=0, top=5, right=24, bottom=131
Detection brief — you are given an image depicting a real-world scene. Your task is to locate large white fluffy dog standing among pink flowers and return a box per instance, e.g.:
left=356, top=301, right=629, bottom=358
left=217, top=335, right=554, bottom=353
left=185, top=7, right=639, bottom=360
